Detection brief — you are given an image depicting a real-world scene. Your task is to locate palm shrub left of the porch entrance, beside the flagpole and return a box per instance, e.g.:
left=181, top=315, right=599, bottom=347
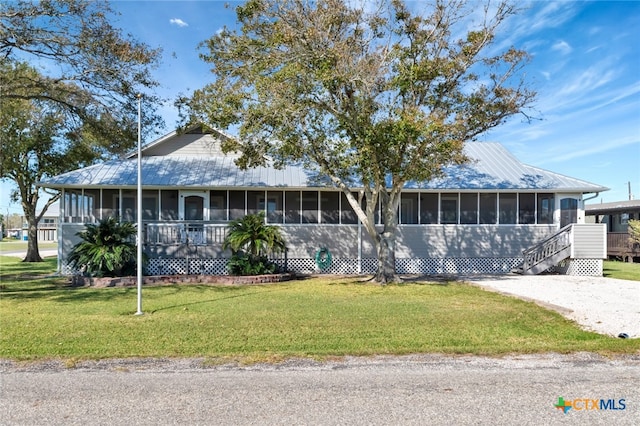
left=69, top=217, right=142, bottom=277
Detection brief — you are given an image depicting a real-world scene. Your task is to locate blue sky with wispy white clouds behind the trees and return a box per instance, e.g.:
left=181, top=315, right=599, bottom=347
left=0, top=1, right=640, bottom=213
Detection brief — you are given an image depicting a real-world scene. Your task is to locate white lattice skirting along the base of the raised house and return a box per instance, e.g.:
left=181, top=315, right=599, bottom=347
left=61, top=257, right=602, bottom=276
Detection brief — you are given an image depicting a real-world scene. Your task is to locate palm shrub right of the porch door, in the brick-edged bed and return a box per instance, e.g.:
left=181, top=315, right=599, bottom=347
left=222, top=212, right=286, bottom=275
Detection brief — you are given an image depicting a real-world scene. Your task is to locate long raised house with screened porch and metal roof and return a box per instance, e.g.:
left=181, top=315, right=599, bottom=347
left=40, top=126, right=607, bottom=275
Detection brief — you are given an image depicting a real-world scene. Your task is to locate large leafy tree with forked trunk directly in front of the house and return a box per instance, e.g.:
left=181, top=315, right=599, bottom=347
left=185, top=0, right=535, bottom=283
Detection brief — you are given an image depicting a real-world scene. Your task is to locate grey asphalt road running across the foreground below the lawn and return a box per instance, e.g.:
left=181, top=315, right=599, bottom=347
left=0, top=354, right=640, bottom=425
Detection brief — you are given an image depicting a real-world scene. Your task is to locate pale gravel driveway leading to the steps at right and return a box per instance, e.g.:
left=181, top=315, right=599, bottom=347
left=463, top=274, right=640, bottom=338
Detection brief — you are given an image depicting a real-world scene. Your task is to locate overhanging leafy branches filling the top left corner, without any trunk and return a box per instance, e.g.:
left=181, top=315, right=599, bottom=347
left=0, top=0, right=162, bottom=156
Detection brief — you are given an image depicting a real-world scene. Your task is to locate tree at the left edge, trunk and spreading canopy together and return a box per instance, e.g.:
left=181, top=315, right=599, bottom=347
left=0, top=0, right=162, bottom=261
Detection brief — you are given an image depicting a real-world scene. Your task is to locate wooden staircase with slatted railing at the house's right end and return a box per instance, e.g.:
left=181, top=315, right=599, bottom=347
left=513, top=224, right=573, bottom=275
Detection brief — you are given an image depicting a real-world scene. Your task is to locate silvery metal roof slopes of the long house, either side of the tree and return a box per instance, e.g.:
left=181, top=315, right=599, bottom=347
left=39, top=142, right=608, bottom=193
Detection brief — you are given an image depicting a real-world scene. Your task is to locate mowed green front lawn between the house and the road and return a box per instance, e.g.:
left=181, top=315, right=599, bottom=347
left=0, top=256, right=640, bottom=362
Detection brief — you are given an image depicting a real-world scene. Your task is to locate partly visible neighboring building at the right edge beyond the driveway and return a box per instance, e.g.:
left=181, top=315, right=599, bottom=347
left=585, top=200, right=640, bottom=262
